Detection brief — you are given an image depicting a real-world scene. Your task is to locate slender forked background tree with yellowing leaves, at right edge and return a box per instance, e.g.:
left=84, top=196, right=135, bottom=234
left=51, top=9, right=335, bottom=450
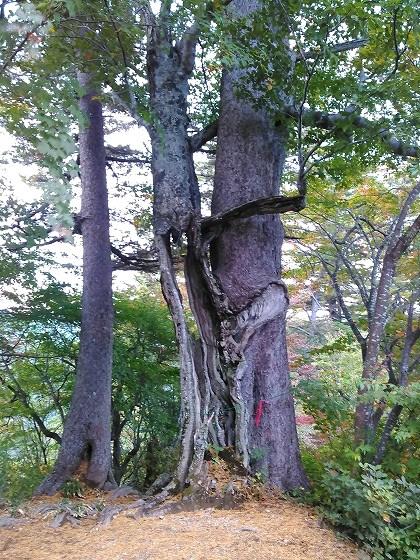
left=288, top=173, right=419, bottom=463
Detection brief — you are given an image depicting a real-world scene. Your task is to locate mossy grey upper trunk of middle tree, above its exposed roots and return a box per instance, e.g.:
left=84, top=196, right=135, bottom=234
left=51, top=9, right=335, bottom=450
left=147, top=14, right=199, bottom=236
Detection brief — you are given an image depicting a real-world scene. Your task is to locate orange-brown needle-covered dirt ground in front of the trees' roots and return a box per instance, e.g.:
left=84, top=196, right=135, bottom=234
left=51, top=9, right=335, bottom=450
left=0, top=499, right=361, bottom=560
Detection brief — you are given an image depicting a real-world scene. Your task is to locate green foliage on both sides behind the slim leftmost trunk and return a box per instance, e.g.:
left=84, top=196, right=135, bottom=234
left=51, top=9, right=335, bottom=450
left=0, top=284, right=179, bottom=501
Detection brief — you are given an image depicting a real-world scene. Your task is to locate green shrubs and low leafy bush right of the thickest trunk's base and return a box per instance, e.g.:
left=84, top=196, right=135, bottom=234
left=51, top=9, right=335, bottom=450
left=296, top=330, right=420, bottom=560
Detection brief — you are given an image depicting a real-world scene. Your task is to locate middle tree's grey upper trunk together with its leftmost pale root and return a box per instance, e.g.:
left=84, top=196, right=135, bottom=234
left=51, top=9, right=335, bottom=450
left=147, top=7, right=207, bottom=488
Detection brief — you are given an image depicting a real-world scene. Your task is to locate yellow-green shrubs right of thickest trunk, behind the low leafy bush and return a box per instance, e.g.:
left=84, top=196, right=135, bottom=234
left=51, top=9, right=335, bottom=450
left=295, top=332, right=420, bottom=481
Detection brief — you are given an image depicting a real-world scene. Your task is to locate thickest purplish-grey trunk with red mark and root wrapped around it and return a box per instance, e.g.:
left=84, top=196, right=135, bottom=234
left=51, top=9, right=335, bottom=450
left=211, top=47, right=307, bottom=489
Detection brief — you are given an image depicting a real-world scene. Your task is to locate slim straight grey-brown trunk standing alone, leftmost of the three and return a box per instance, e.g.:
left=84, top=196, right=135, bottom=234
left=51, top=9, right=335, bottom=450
left=37, top=73, right=113, bottom=494
